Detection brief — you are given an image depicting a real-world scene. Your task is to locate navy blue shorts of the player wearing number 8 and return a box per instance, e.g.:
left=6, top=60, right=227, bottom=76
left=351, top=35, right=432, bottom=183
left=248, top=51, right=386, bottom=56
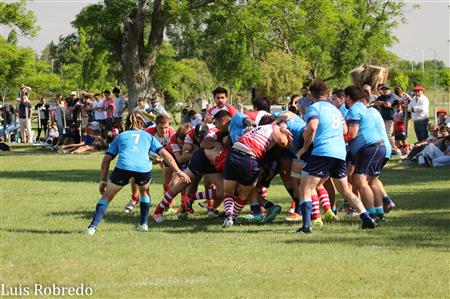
left=302, top=155, right=347, bottom=179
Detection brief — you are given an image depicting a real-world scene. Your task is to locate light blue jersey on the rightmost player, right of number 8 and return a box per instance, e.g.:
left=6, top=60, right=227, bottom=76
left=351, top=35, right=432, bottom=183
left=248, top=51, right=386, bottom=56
left=346, top=102, right=383, bottom=156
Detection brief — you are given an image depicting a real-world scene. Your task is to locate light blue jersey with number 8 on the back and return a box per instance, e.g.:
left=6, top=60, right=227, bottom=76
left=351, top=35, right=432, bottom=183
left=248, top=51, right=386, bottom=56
left=305, top=101, right=347, bottom=161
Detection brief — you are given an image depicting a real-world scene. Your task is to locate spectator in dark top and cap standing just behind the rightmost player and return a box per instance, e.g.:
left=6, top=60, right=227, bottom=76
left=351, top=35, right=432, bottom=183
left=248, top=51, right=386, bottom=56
left=373, top=84, right=400, bottom=155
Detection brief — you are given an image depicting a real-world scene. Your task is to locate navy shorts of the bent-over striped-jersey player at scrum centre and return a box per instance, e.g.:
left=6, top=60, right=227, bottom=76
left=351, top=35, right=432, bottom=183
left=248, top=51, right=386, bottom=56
left=223, top=149, right=259, bottom=186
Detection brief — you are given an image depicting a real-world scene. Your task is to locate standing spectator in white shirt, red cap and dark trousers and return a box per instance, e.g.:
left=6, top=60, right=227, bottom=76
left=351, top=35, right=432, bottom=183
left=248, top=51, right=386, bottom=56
left=408, top=86, right=429, bottom=142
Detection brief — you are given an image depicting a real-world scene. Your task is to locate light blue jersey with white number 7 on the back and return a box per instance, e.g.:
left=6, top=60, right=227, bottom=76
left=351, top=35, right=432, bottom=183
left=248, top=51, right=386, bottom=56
left=106, top=130, right=163, bottom=172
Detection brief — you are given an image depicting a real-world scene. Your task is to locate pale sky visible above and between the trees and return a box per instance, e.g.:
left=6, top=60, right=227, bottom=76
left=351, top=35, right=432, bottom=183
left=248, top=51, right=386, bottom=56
left=0, top=0, right=450, bottom=66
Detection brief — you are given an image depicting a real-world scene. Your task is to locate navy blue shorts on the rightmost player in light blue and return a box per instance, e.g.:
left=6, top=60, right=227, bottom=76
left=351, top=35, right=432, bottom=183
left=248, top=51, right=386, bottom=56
left=355, top=144, right=386, bottom=177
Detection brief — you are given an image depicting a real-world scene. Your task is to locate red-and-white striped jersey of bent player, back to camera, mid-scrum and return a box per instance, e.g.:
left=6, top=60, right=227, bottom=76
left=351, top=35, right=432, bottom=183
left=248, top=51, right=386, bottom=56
left=235, top=124, right=278, bottom=159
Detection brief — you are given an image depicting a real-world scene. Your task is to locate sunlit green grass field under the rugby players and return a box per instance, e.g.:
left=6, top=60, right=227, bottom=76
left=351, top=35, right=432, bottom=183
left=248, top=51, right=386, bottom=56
left=0, top=146, right=450, bottom=298
